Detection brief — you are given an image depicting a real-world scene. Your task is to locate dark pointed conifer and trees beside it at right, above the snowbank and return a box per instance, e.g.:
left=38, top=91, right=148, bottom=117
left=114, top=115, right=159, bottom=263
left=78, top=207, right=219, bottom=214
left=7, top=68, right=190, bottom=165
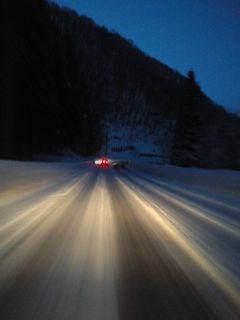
left=171, top=71, right=240, bottom=169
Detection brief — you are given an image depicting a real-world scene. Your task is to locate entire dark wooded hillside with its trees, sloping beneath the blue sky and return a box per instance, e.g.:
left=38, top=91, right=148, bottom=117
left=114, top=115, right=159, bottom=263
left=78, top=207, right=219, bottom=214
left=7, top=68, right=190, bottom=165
left=0, top=0, right=240, bottom=168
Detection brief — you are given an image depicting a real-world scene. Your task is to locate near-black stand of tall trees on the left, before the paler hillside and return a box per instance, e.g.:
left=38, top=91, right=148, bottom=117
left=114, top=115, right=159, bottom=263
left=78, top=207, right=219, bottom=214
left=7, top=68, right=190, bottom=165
left=0, top=0, right=101, bottom=158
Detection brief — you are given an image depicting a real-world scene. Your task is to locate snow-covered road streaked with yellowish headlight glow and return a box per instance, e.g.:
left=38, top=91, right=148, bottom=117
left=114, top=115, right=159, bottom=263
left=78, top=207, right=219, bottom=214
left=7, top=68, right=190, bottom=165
left=0, top=161, right=240, bottom=320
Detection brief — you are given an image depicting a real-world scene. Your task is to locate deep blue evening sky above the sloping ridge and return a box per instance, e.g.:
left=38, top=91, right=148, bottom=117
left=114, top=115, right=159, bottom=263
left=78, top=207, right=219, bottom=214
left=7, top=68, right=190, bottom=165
left=55, top=0, right=240, bottom=112
